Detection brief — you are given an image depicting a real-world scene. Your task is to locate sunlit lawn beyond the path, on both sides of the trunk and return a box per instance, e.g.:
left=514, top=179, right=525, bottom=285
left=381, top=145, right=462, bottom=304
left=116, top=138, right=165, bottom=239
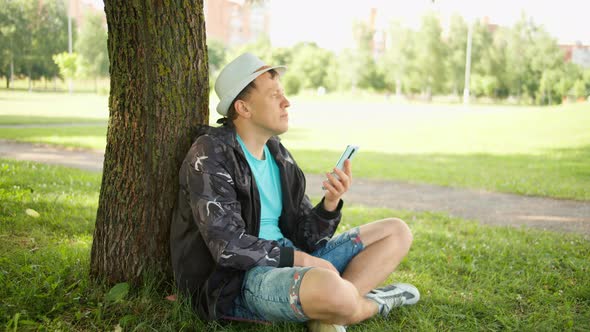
left=0, top=90, right=590, bottom=200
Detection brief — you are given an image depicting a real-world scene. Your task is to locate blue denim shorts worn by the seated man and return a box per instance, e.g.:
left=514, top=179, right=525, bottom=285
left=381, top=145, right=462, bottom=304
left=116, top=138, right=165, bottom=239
left=227, top=227, right=364, bottom=322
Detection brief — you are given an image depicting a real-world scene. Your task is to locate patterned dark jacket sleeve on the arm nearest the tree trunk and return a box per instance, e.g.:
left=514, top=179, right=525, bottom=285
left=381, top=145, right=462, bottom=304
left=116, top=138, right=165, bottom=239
left=183, top=135, right=293, bottom=270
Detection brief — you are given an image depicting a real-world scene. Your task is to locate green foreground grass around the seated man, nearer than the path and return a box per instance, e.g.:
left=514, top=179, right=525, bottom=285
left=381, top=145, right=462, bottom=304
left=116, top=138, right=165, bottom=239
left=0, top=160, right=590, bottom=332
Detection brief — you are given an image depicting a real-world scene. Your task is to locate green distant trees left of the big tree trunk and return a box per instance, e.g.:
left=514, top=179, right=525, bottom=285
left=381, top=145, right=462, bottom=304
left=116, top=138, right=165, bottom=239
left=0, top=0, right=108, bottom=88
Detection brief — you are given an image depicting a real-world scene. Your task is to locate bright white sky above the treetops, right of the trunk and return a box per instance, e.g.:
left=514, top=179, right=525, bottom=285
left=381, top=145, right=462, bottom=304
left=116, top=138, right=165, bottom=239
left=270, top=0, right=590, bottom=51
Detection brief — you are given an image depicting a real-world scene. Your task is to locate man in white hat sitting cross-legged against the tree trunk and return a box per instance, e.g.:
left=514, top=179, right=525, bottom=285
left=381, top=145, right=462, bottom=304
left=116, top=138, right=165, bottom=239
left=171, top=53, right=420, bottom=331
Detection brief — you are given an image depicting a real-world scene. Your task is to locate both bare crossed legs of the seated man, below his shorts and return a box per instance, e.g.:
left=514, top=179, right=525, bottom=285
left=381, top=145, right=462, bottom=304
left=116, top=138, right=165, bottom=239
left=299, top=219, right=412, bottom=325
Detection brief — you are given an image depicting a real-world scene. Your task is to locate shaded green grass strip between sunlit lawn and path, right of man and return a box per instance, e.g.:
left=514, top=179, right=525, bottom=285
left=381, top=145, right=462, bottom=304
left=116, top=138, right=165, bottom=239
left=292, top=144, right=590, bottom=200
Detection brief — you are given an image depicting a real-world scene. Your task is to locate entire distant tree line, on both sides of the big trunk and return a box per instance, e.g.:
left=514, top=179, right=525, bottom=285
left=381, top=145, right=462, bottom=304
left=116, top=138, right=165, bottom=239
left=0, top=0, right=590, bottom=104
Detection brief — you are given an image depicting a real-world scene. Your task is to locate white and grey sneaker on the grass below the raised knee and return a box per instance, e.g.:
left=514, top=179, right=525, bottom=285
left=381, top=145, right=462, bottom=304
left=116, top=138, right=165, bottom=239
left=365, top=283, right=420, bottom=317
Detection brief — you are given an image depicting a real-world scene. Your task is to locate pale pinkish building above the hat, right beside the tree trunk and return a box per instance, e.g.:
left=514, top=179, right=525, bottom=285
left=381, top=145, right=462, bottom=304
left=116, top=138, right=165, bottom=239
left=203, top=0, right=270, bottom=47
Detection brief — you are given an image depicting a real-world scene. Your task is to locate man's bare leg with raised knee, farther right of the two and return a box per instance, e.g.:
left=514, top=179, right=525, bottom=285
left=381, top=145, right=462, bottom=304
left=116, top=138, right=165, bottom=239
left=342, top=218, right=413, bottom=295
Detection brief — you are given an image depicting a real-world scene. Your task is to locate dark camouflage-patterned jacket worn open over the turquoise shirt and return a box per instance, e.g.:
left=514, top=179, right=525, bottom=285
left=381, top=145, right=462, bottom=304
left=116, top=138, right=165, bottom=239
left=170, top=126, right=342, bottom=320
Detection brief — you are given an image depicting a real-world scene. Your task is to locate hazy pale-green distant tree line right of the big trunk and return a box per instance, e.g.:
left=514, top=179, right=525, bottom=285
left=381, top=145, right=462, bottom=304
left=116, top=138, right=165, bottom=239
left=208, top=14, right=590, bottom=105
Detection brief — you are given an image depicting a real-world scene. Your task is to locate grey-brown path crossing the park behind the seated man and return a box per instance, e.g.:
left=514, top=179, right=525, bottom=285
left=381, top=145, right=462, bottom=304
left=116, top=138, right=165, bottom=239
left=0, top=140, right=590, bottom=238
